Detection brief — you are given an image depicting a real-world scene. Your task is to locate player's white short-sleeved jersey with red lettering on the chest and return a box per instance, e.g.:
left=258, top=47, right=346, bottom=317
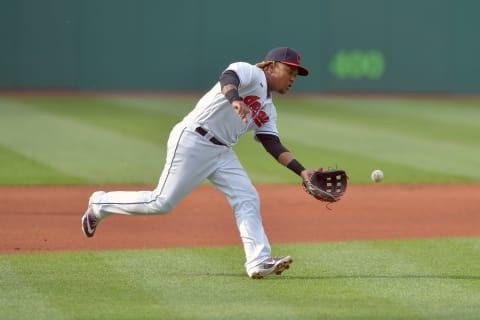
left=182, top=62, right=278, bottom=146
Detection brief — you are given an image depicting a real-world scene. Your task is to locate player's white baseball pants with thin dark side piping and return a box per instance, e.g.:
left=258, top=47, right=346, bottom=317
left=92, top=123, right=271, bottom=273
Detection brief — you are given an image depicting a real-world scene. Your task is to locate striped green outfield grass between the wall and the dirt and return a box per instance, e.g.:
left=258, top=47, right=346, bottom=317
left=0, top=96, right=480, bottom=185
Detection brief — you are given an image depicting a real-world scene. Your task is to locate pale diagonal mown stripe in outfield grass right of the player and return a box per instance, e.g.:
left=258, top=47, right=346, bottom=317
left=279, top=113, right=480, bottom=179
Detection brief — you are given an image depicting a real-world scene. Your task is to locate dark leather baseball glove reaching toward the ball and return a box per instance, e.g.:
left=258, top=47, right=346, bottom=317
left=303, top=169, right=348, bottom=202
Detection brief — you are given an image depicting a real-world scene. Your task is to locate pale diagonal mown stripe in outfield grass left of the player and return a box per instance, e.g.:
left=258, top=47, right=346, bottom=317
left=0, top=100, right=165, bottom=184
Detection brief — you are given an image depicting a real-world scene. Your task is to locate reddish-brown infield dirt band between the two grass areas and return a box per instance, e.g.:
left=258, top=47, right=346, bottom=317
left=0, top=184, right=480, bottom=254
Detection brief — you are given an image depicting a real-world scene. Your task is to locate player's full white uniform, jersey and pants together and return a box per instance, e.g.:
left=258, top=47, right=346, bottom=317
left=91, top=62, right=278, bottom=273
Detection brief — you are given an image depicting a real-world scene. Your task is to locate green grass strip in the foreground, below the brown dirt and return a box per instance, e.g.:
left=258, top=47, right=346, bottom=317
left=0, top=238, right=480, bottom=320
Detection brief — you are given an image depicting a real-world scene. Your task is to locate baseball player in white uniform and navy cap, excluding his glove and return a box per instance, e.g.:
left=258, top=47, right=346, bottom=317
left=82, top=47, right=314, bottom=279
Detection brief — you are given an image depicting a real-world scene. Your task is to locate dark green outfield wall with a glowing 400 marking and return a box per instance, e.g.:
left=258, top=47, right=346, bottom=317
left=0, top=0, right=480, bottom=93
